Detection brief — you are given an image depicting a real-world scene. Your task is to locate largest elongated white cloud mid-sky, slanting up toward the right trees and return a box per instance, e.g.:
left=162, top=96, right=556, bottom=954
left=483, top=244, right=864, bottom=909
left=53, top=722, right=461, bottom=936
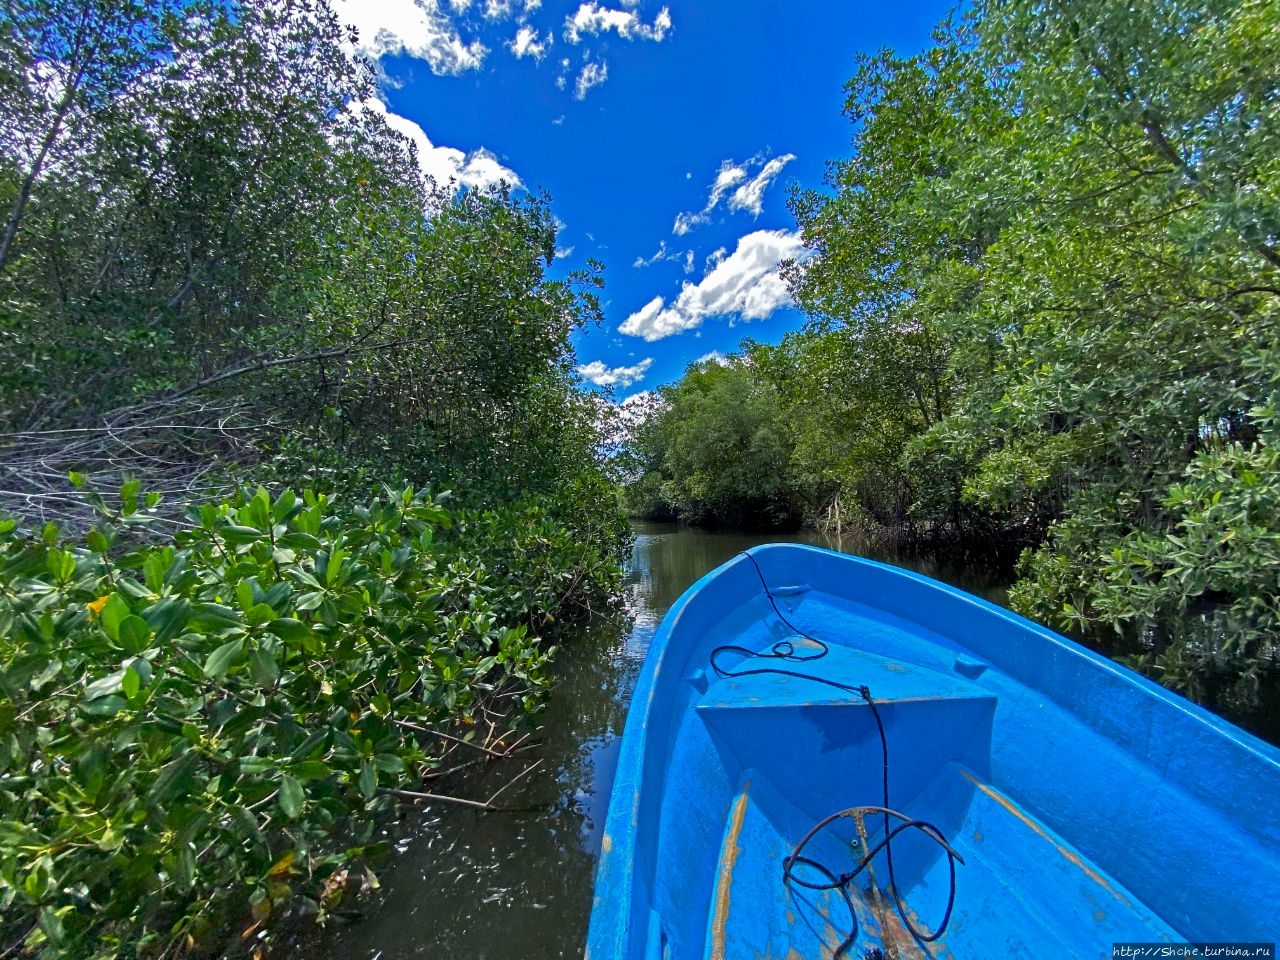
left=618, top=230, right=805, bottom=340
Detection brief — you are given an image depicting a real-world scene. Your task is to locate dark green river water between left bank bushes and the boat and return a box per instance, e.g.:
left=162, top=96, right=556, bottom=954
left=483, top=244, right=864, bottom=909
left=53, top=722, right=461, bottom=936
left=307, top=524, right=1004, bottom=960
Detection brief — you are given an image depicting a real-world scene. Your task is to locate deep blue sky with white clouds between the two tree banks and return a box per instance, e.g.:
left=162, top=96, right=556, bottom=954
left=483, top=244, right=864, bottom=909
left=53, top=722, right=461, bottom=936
left=334, top=0, right=951, bottom=398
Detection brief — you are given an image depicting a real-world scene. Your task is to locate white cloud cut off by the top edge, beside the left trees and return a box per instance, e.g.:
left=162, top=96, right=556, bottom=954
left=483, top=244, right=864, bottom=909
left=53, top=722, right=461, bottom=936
left=333, top=0, right=489, bottom=76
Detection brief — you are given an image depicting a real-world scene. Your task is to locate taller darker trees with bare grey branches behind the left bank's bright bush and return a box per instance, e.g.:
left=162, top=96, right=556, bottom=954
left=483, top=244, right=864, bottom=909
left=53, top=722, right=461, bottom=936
left=0, top=0, right=616, bottom=517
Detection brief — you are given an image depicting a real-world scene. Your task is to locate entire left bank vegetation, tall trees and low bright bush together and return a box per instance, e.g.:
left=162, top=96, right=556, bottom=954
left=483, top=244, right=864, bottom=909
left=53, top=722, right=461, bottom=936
left=0, top=0, right=627, bottom=957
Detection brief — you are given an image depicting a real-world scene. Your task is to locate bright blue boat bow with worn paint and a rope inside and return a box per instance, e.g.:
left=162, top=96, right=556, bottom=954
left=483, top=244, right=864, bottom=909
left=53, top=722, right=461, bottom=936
left=588, top=544, right=1280, bottom=960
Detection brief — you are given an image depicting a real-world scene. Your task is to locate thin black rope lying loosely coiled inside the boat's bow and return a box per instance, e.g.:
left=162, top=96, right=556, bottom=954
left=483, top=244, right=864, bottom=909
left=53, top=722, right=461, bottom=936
left=710, top=550, right=964, bottom=957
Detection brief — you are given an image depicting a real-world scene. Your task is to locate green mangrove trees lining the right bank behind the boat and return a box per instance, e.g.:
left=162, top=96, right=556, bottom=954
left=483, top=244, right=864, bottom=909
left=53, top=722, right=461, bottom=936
left=628, top=0, right=1280, bottom=717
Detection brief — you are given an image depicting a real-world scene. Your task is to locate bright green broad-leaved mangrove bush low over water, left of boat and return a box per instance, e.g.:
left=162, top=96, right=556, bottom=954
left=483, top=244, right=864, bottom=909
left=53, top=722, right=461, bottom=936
left=0, top=488, right=627, bottom=956
